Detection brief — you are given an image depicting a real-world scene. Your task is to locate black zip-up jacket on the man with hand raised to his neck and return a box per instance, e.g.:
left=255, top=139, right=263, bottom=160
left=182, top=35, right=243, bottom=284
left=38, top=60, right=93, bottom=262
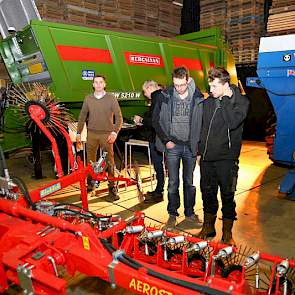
left=199, top=85, right=249, bottom=161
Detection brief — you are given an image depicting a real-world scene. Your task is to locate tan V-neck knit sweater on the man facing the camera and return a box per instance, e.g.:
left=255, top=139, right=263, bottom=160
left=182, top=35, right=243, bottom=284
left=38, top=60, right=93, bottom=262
left=77, top=93, right=123, bottom=133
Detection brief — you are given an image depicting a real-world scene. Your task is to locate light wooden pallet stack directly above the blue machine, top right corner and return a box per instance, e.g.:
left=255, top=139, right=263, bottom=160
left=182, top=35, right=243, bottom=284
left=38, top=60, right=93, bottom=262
left=267, top=0, right=295, bottom=36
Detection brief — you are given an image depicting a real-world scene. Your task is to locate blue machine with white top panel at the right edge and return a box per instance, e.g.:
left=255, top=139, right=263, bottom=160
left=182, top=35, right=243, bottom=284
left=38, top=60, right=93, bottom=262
left=247, top=34, right=295, bottom=198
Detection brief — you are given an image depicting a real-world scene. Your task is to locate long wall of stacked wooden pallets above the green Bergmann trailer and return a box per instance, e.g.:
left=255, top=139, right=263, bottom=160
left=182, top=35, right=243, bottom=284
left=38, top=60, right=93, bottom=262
left=35, top=0, right=181, bottom=37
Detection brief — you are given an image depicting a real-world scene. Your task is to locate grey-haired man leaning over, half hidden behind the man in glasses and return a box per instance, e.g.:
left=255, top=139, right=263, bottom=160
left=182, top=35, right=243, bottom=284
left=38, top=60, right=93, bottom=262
left=133, top=80, right=165, bottom=203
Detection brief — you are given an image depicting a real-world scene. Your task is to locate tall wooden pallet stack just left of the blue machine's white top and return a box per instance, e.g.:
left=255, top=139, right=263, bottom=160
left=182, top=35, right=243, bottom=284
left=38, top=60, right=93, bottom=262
left=225, top=0, right=264, bottom=63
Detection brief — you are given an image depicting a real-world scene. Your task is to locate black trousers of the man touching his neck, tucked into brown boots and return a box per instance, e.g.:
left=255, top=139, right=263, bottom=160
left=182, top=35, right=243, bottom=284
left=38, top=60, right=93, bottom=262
left=200, top=160, right=239, bottom=220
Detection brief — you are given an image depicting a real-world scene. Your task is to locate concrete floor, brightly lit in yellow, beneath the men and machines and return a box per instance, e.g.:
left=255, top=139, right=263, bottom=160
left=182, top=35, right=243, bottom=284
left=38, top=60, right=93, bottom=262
left=4, top=141, right=295, bottom=294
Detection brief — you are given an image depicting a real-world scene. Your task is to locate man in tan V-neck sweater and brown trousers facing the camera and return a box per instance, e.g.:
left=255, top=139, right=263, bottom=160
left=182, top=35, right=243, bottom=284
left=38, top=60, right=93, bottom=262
left=77, top=76, right=123, bottom=202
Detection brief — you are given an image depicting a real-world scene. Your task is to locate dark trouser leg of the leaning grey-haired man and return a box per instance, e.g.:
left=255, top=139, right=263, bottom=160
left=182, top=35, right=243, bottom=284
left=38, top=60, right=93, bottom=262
left=149, top=142, right=165, bottom=194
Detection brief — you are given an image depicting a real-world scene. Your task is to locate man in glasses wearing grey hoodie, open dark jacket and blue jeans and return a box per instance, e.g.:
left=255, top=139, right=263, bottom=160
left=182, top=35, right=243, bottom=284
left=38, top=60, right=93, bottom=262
left=153, top=67, right=203, bottom=229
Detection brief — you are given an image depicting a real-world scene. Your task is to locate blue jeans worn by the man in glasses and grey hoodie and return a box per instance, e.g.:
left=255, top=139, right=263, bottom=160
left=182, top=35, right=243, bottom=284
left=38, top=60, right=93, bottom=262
left=166, top=144, right=196, bottom=217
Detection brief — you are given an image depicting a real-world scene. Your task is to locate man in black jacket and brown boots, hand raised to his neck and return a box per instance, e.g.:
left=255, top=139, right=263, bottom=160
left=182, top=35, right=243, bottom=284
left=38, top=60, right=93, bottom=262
left=199, top=68, right=249, bottom=245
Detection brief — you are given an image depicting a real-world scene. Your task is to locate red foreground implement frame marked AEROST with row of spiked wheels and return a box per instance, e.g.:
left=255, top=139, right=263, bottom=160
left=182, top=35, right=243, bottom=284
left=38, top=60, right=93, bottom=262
left=0, top=185, right=295, bottom=295
